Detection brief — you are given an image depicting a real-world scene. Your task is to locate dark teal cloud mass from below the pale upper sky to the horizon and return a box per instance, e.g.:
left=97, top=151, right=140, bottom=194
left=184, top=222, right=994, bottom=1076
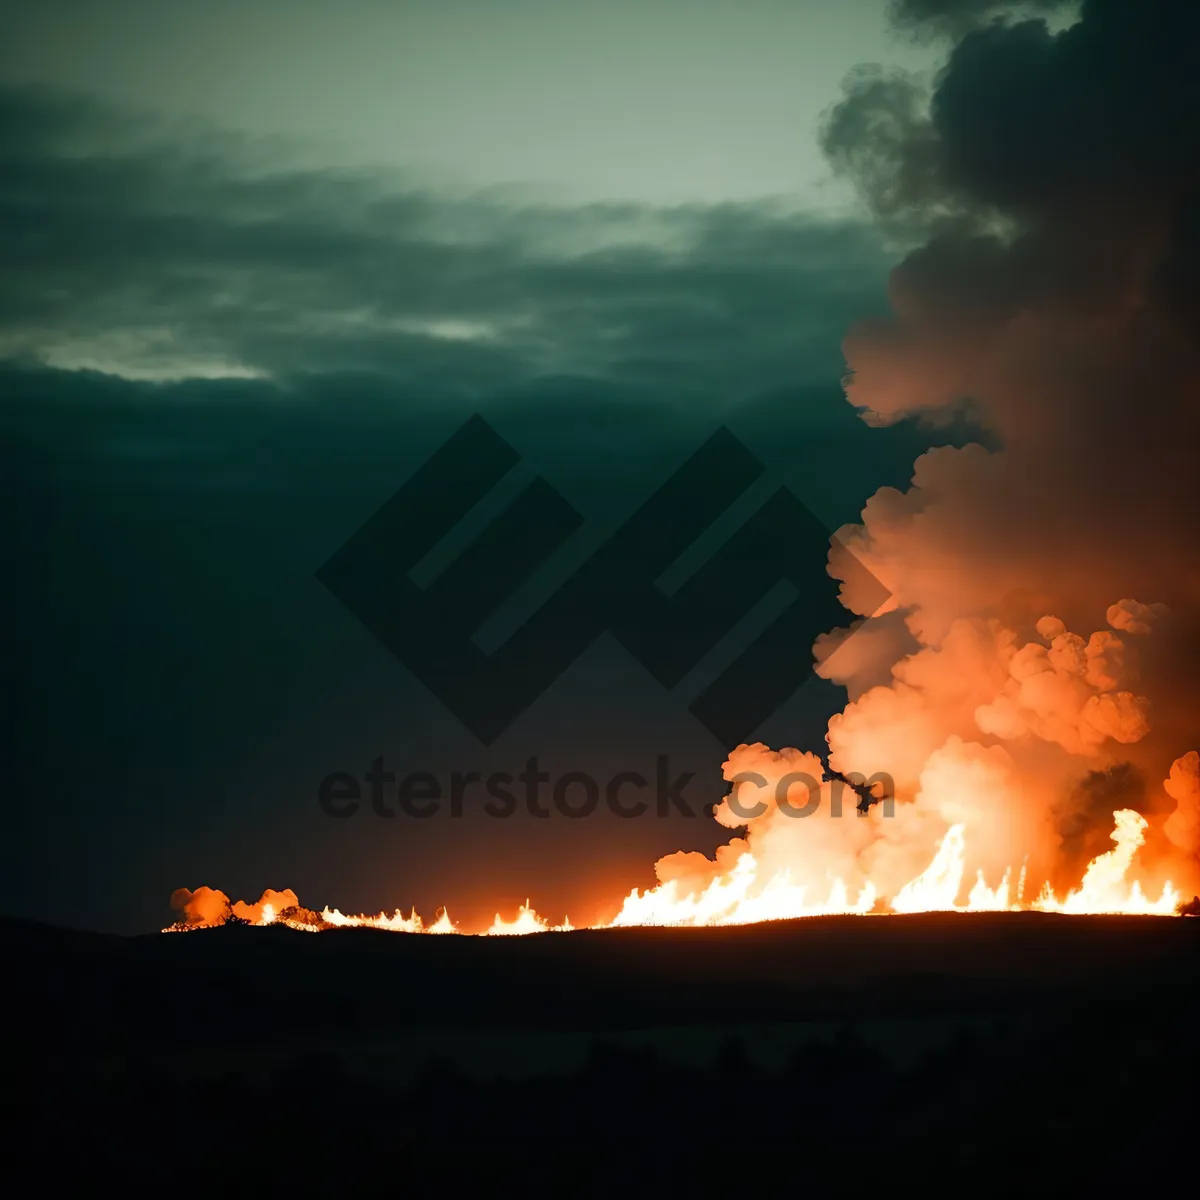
left=0, top=79, right=964, bottom=931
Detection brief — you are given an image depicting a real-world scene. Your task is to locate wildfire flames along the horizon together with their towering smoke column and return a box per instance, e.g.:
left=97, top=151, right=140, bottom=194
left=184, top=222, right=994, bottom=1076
left=154, top=4, right=1200, bottom=935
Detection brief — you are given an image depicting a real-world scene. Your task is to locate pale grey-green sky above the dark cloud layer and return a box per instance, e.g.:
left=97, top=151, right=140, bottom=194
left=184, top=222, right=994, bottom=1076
left=0, top=0, right=931, bottom=208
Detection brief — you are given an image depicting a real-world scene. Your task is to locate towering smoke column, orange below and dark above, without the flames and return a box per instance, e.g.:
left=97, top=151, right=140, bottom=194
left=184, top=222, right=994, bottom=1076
left=628, top=0, right=1200, bottom=907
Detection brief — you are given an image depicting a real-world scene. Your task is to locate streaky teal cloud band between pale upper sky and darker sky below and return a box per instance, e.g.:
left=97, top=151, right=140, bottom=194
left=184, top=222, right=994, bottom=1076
left=0, top=90, right=886, bottom=401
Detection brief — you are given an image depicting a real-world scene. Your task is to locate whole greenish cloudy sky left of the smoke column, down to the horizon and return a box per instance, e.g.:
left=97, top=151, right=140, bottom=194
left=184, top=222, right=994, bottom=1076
left=0, top=0, right=988, bottom=932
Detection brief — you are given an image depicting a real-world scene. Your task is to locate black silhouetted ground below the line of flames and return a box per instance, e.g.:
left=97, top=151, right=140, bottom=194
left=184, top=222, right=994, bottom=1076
left=0, top=913, right=1200, bottom=1196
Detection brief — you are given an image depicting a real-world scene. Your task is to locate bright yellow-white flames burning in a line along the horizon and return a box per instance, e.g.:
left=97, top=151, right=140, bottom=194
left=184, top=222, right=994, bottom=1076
left=163, top=809, right=1181, bottom=936
